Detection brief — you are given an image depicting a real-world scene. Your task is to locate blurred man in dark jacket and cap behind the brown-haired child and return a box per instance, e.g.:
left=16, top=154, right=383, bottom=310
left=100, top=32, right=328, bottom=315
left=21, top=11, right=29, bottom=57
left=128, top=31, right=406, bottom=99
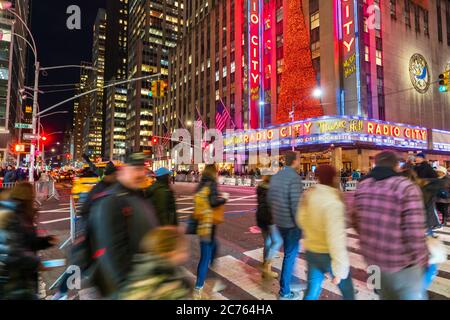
left=87, top=153, right=159, bottom=298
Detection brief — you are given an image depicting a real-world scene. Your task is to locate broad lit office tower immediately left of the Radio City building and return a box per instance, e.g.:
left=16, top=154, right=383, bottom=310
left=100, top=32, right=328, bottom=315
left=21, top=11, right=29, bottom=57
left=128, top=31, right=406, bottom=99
left=126, top=0, right=185, bottom=152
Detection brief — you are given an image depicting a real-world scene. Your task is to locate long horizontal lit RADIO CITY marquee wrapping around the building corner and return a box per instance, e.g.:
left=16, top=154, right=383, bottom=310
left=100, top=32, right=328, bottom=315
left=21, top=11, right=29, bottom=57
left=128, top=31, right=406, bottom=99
left=224, top=117, right=428, bottom=151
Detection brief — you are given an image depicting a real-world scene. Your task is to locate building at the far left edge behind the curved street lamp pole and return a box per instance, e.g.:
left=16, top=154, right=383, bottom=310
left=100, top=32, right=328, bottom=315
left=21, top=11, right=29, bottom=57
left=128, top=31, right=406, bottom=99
left=0, top=0, right=29, bottom=164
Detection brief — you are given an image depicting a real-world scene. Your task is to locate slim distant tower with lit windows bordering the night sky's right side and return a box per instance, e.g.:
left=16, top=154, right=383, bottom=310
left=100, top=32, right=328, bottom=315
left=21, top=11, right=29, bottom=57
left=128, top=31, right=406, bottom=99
left=84, top=9, right=106, bottom=158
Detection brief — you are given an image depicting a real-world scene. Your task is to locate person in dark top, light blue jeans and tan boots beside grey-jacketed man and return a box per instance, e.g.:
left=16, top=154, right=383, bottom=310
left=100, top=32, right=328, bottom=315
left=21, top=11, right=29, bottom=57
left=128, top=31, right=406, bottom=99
left=256, top=169, right=283, bottom=278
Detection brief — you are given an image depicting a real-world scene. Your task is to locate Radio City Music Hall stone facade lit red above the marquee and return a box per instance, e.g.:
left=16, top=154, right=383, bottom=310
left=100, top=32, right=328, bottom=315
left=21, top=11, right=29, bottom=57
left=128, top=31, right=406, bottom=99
left=162, top=0, right=450, bottom=170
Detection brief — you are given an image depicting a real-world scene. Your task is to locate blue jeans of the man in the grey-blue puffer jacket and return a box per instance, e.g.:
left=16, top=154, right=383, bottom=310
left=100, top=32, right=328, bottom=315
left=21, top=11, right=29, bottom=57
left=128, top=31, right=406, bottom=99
left=278, top=227, right=302, bottom=296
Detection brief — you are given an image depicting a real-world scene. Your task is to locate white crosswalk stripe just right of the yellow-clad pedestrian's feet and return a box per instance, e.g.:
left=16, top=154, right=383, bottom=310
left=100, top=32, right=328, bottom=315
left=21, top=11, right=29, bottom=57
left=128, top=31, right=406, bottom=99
left=212, top=256, right=277, bottom=300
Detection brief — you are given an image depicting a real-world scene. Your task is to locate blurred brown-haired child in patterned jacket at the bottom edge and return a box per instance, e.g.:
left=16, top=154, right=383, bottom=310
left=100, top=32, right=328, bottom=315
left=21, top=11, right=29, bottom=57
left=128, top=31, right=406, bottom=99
left=119, top=226, right=192, bottom=300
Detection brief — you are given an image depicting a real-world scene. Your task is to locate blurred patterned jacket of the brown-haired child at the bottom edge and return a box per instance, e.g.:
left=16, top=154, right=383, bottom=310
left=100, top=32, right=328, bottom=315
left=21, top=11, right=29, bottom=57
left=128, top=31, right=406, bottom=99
left=119, top=254, right=192, bottom=300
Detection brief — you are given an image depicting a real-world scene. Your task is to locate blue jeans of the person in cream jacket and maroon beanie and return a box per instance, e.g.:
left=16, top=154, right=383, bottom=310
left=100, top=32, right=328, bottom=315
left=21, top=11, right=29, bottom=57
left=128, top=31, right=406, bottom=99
left=304, top=252, right=355, bottom=300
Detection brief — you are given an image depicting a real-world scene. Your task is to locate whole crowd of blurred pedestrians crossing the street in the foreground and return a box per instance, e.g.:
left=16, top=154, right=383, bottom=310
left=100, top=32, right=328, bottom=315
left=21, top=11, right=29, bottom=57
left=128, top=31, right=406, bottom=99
left=0, top=151, right=450, bottom=300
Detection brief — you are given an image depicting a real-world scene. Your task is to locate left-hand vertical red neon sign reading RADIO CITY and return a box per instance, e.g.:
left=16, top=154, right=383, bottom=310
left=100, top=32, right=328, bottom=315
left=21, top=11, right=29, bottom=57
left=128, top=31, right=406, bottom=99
left=249, top=0, right=261, bottom=129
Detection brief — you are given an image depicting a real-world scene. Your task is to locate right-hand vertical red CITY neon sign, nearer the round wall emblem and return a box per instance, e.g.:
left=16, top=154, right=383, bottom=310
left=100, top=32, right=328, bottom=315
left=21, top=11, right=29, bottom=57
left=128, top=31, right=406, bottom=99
left=341, top=0, right=356, bottom=78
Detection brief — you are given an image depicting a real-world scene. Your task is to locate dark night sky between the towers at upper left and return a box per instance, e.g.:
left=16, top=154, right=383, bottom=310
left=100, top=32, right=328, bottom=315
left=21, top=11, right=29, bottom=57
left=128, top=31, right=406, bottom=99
left=27, top=0, right=106, bottom=139
